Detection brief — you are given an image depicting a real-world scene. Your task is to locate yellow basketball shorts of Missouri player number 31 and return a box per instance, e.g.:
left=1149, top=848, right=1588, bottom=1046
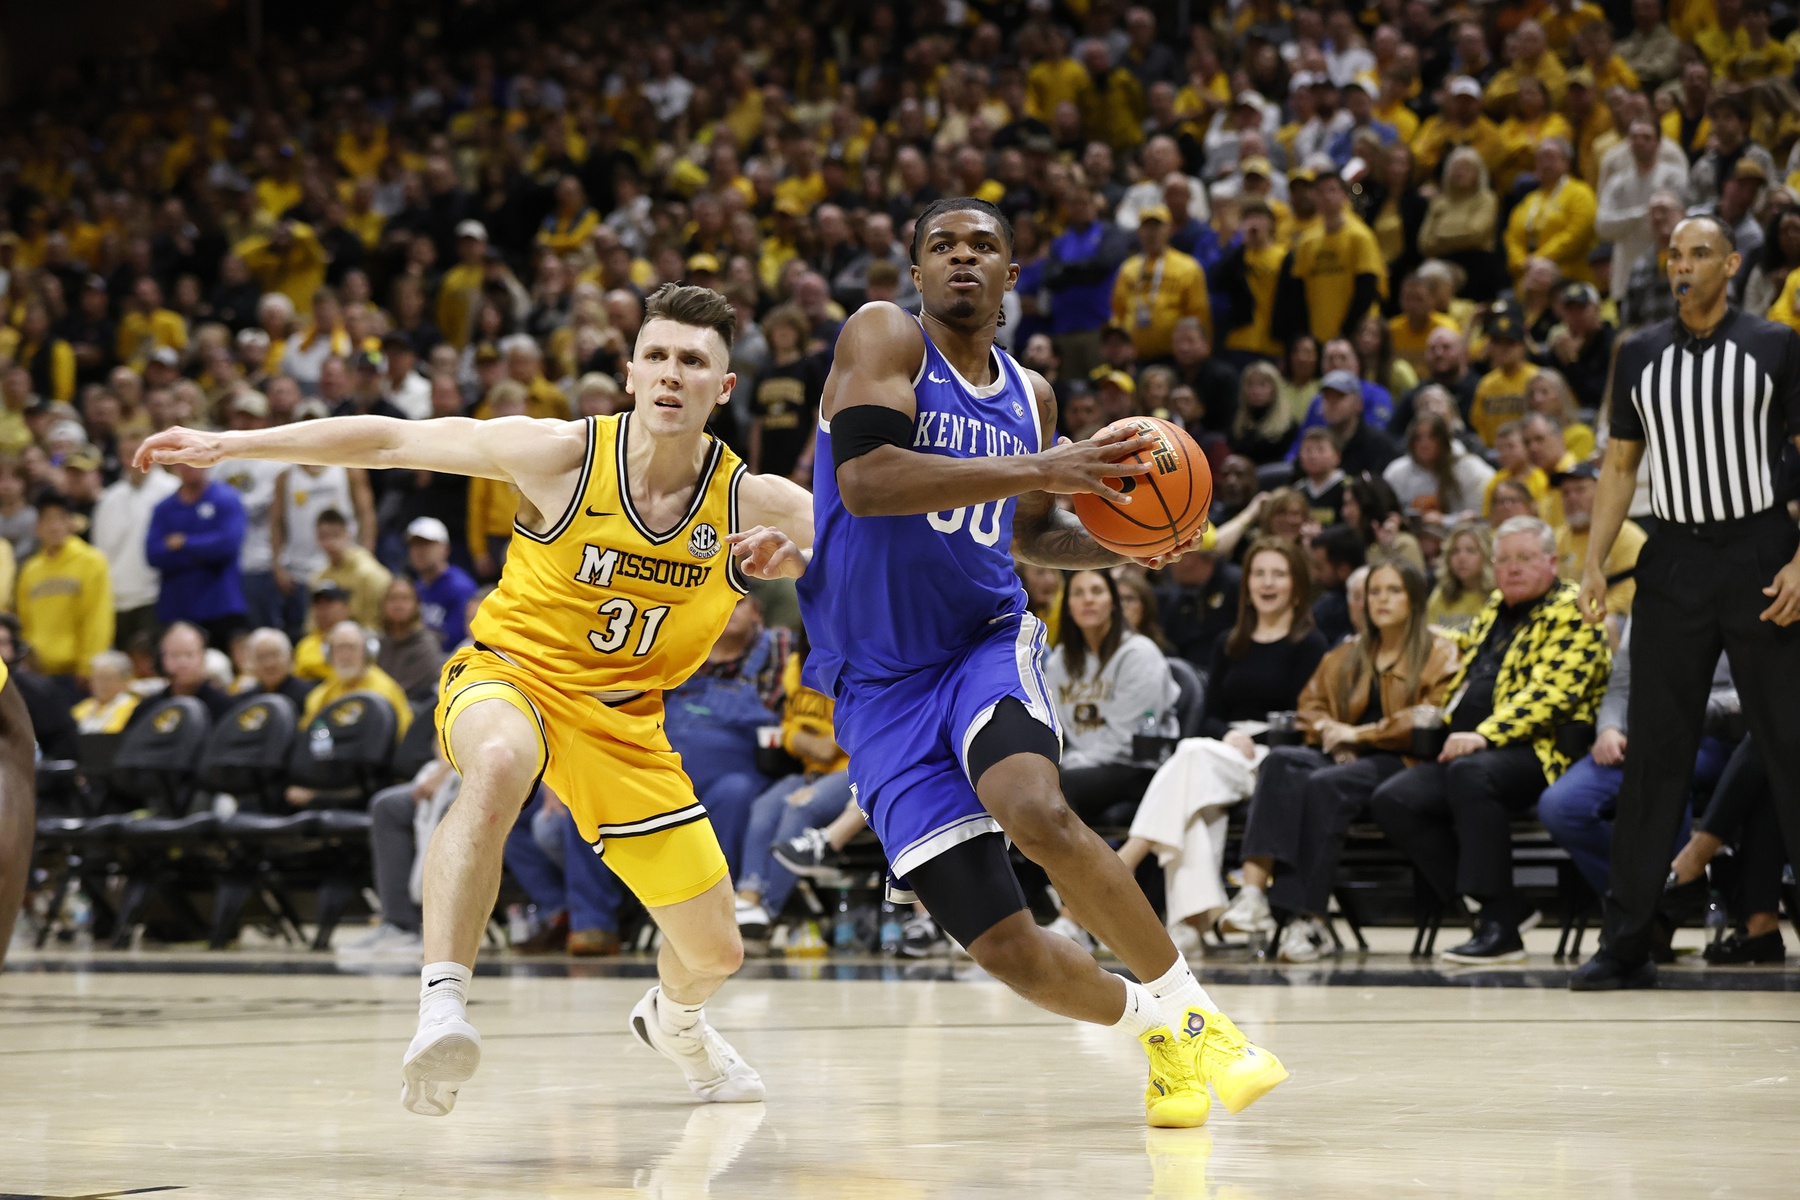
left=437, top=646, right=727, bottom=909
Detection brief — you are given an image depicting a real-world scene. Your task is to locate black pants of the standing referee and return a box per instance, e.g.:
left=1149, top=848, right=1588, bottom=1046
left=1602, top=509, right=1800, bottom=964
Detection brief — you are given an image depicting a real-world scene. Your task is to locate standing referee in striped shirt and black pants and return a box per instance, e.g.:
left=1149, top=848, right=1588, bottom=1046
left=1570, top=216, right=1800, bottom=991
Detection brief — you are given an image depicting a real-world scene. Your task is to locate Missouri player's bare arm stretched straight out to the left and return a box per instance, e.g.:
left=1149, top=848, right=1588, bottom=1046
left=137, top=417, right=587, bottom=496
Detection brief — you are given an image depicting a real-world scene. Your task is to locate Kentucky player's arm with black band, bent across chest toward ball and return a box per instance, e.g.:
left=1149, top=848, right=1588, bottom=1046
left=823, top=302, right=1152, bottom=516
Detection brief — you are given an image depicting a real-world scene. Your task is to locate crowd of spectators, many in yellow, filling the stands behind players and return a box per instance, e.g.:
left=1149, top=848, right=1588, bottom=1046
left=0, top=0, right=1800, bottom=961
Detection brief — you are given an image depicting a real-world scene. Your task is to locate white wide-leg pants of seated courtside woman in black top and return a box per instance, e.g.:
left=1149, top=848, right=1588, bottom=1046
left=1130, top=738, right=1269, bottom=925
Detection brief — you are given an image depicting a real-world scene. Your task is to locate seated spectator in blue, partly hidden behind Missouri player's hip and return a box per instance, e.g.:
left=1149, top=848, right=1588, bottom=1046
left=662, top=596, right=787, bottom=878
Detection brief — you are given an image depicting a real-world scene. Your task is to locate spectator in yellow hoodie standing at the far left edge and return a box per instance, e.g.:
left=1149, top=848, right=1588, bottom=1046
left=18, top=491, right=113, bottom=676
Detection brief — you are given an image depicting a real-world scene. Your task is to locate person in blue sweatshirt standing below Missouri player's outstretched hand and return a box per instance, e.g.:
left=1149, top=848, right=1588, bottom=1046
left=144, top=464, right=245, bottom=649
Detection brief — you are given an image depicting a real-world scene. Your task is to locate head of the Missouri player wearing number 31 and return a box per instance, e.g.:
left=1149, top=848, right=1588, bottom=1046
left=625, top=284, right=738, bottom=435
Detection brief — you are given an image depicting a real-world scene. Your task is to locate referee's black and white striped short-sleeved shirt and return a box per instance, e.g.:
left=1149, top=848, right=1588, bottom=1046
left=1611, top=308, right=1800, bottom=525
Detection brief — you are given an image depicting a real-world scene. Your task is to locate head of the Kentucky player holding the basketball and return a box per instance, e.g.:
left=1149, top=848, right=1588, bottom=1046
left=913, top=196, right=1019, bottom=331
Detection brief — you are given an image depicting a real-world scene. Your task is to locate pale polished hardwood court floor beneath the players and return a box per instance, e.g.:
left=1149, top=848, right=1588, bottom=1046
left=0, top=955, right=1800, bottom=1200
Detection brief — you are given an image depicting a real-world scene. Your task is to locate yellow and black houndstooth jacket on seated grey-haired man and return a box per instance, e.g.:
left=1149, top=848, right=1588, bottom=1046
left=1449, top=579, right=1613, bottom=783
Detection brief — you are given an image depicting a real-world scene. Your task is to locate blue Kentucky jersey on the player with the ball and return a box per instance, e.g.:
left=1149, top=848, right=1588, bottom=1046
left=799, top=323, right=1042, bottom=696
